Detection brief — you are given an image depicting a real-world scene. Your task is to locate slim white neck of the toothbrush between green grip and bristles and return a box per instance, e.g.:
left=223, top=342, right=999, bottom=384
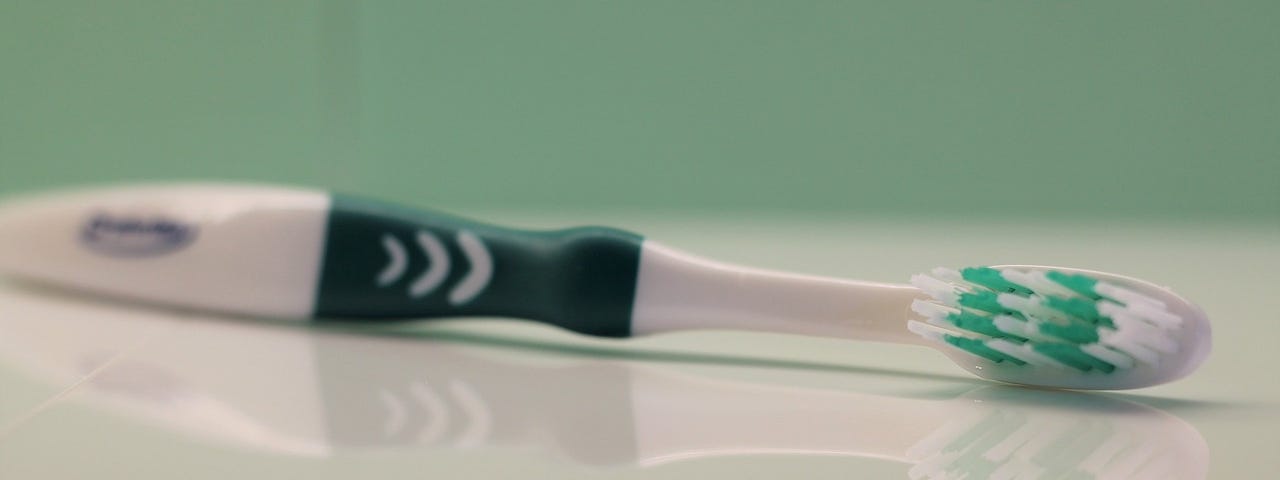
left=631, top=241, right=922, bottom=343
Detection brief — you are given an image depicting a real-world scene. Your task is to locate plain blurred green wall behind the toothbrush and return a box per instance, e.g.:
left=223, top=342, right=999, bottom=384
left=0, top=0, right=1280, bottom=221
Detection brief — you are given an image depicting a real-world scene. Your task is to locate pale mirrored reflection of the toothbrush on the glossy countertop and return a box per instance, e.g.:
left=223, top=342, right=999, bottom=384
left=0, top=284, right=1208, bottom=480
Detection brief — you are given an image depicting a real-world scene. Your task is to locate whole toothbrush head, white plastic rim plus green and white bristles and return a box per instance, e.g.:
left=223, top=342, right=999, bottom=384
left=908, top=265, right=1211, bottom=390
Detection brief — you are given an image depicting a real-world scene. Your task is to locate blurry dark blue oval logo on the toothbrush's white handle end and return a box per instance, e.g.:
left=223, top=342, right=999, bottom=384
left=81, top=214, right=196, bottom=257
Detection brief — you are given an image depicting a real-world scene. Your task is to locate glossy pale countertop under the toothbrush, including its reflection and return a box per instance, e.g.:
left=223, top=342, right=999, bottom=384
left=0, top=214, right=1280, bottom=479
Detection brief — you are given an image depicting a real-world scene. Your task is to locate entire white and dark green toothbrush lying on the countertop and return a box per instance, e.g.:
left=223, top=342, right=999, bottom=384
left=0, top=184, right=1210, bottom=389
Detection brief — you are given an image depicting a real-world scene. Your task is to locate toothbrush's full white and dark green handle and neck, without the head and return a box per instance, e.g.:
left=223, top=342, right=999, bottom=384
left=0, top=183, right=920, bottom=343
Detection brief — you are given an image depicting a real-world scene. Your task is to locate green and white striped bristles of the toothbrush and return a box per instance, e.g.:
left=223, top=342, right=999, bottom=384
left=908, top=268, right=1183, bottom=374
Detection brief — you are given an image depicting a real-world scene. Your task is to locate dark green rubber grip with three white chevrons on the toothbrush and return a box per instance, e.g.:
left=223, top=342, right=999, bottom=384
left=315, top=196, right=643, bottom=337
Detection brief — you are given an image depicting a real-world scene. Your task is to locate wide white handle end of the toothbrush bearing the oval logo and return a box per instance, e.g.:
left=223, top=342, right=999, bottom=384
left=0, top=184, right=330, bottom=319
